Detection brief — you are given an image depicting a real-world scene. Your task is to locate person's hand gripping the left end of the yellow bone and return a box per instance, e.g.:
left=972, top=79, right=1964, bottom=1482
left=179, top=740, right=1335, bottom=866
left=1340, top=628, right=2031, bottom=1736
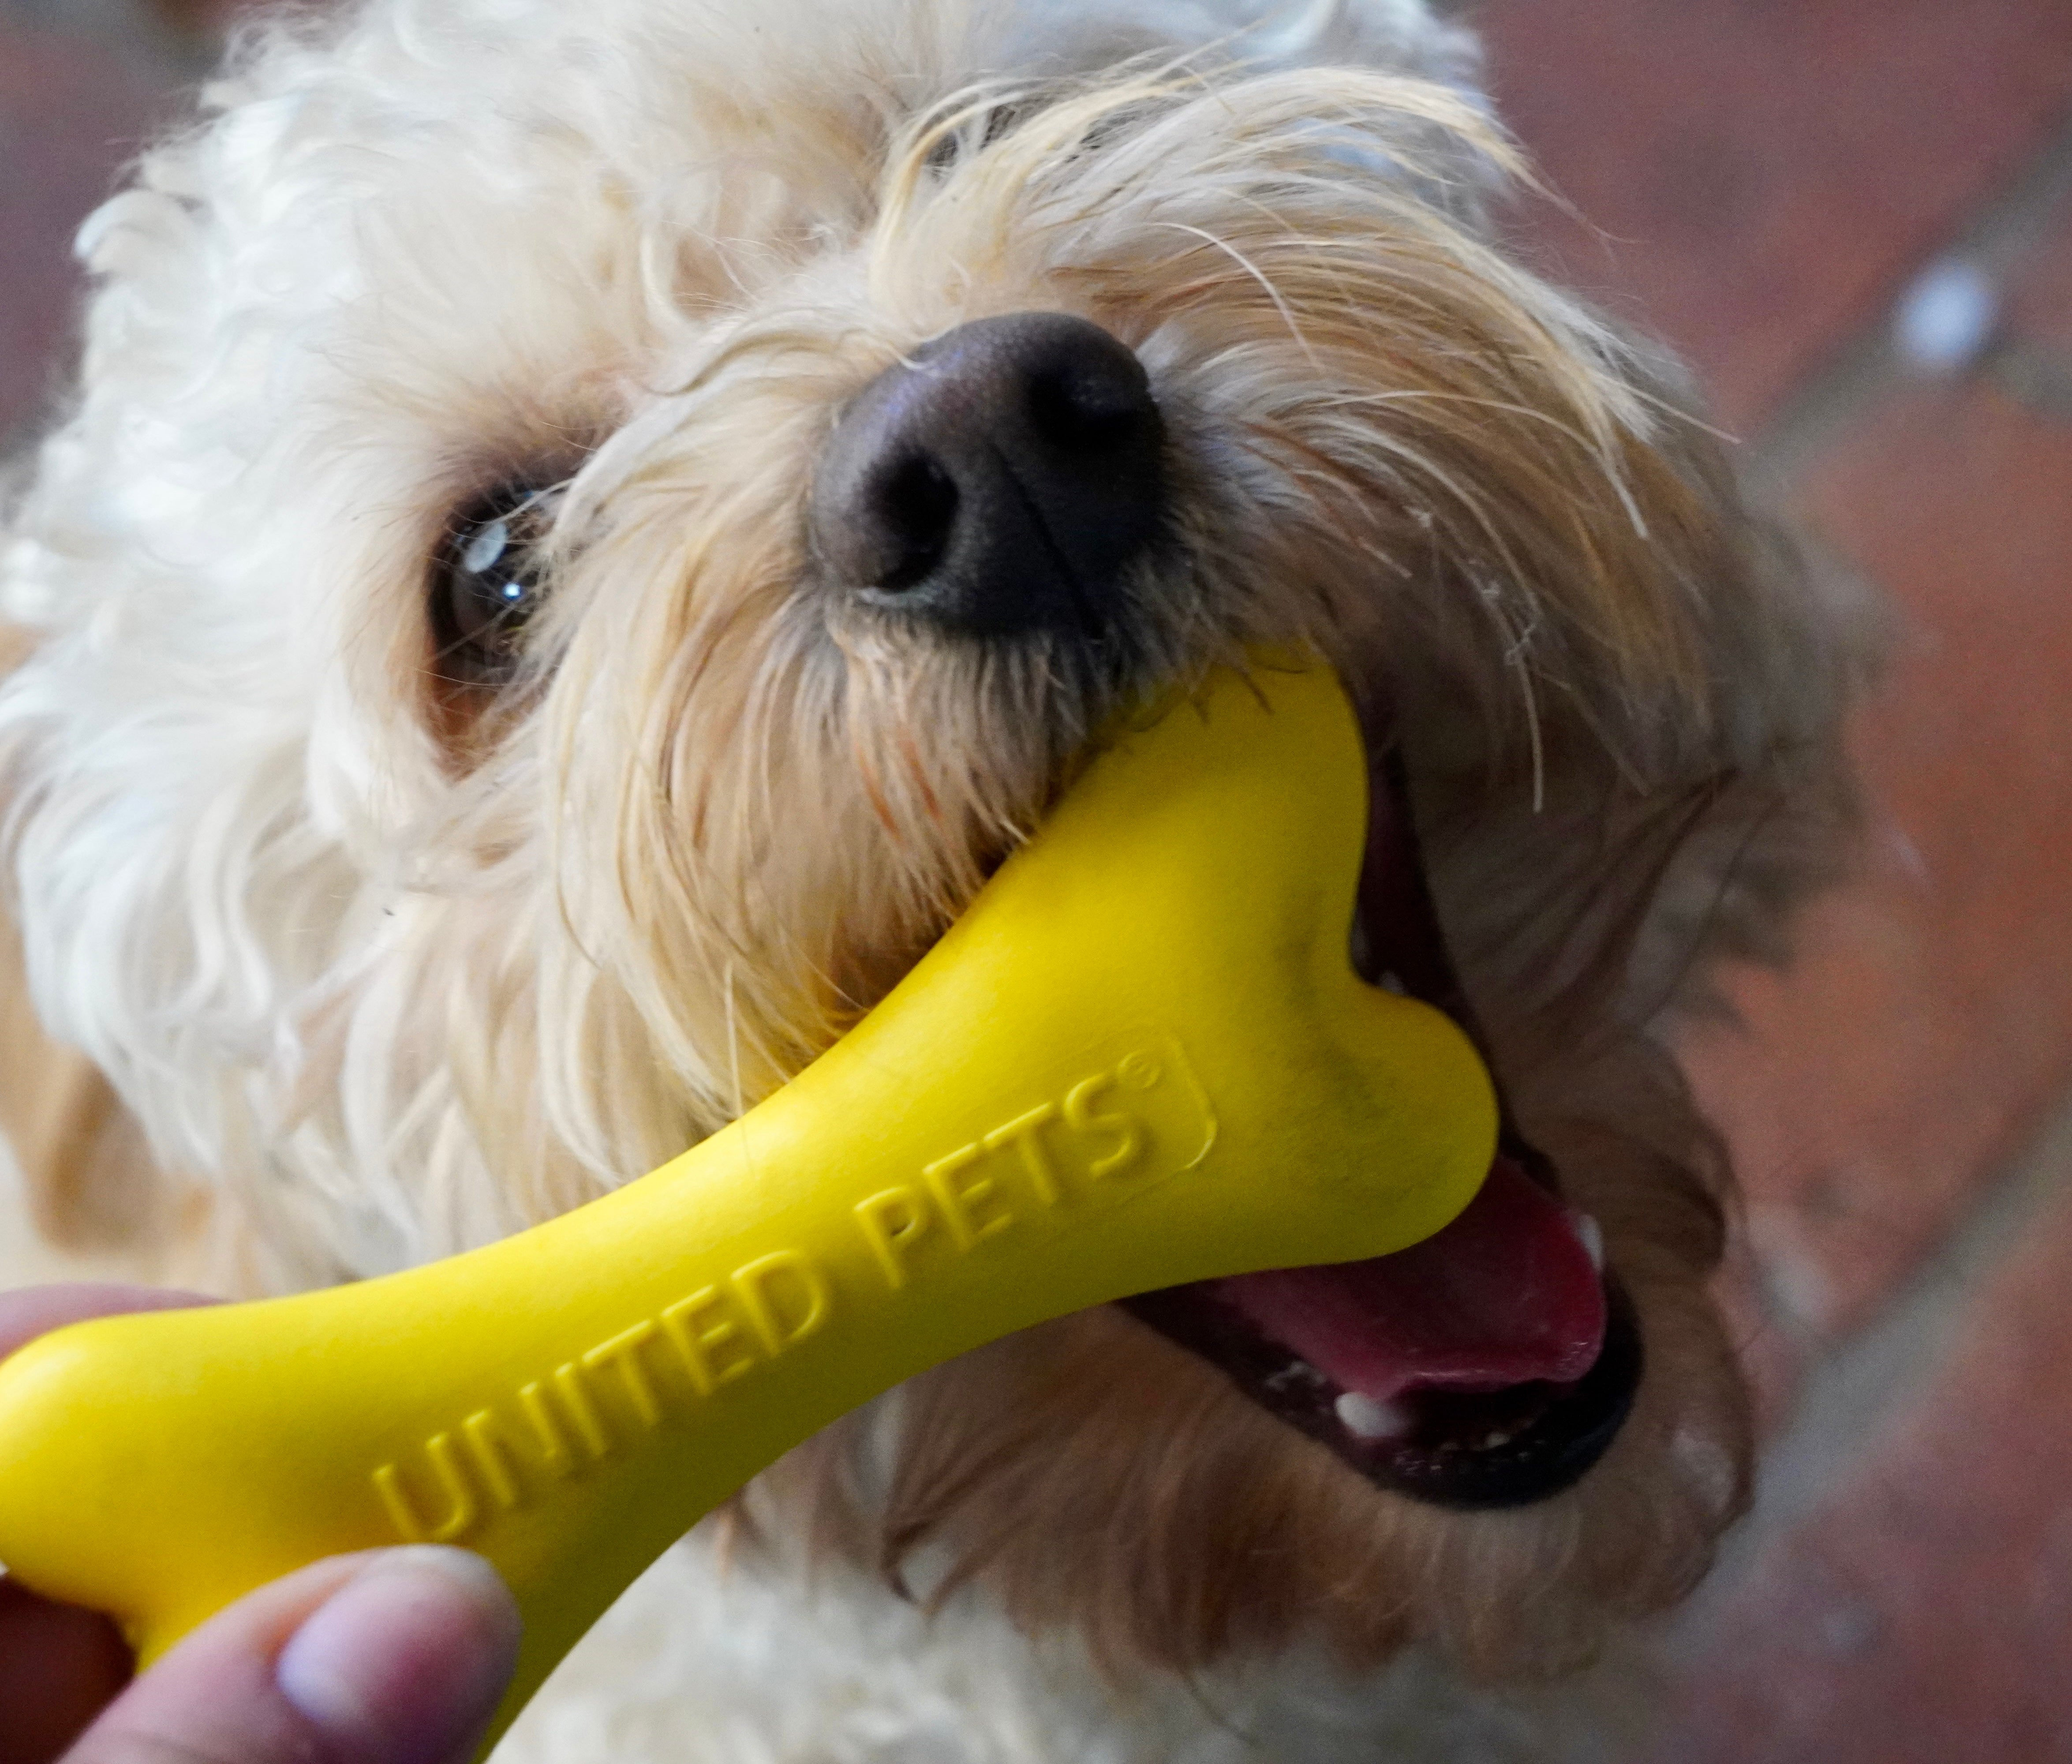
left=0, top=1287, right=518, bottom=1764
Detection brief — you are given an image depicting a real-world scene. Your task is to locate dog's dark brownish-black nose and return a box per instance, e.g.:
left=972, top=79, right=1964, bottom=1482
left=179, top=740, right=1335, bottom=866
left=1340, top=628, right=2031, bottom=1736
left=810, top=313, right=1164, bottom=634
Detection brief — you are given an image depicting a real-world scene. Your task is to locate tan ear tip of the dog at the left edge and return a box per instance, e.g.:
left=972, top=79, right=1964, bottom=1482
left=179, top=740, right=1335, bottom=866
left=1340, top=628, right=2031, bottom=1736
left=0, top=624, right=166, bottom=1252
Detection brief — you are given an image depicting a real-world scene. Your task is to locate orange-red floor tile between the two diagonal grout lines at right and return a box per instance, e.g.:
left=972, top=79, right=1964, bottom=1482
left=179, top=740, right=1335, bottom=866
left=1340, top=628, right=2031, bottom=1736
left=1697, top=373, right=2072, bottom=1333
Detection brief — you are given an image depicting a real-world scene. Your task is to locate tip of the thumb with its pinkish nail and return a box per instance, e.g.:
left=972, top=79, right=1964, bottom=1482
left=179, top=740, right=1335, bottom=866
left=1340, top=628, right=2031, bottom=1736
left=273, top=1544, right=518, bottom=1764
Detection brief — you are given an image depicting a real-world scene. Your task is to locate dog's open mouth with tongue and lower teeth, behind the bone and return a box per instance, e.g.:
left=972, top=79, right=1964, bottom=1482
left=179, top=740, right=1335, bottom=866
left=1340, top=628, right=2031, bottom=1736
left=1125, top=738, right=1641, bottom=1507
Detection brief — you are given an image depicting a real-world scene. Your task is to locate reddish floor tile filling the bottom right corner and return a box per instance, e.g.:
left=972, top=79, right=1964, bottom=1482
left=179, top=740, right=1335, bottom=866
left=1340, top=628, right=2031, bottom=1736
left=1645, top=1169, right=2072, bottom=1764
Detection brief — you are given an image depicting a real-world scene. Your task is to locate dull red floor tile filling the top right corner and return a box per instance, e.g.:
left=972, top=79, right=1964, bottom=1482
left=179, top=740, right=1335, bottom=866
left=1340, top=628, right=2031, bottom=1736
left=1475, top=0, right=2072, bottom=429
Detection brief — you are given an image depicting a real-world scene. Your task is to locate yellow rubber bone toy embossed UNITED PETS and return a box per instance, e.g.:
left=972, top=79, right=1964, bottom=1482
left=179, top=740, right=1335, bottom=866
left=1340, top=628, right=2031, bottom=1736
left=0, top=668, right=1496, bottom=1731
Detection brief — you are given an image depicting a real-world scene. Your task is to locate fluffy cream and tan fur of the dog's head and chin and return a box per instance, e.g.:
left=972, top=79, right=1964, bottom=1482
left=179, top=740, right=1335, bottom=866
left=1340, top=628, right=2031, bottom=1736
left=0, top=0, right=1865, bottom=1756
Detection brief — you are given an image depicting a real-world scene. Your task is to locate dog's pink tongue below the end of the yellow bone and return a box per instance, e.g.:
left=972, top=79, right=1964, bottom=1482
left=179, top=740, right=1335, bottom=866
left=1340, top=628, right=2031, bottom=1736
left=1208, top=1157, right=1604, bottom=1401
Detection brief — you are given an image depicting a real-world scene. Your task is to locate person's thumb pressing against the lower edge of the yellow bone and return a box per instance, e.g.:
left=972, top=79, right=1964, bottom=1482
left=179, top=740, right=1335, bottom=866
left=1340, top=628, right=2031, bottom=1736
left=62, top=1548, right=518, bottom=1764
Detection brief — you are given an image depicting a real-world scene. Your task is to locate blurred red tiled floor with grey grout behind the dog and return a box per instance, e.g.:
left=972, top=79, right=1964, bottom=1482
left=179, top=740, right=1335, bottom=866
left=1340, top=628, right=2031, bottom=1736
left=12, top=0, right=2072, bottom=1764
